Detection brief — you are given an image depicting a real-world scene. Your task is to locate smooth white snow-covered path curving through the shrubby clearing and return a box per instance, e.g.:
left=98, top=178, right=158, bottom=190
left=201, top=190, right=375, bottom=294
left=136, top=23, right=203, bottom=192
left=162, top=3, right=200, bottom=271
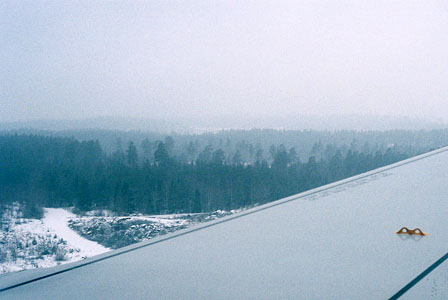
left=43, top=208, right=110, bottom=257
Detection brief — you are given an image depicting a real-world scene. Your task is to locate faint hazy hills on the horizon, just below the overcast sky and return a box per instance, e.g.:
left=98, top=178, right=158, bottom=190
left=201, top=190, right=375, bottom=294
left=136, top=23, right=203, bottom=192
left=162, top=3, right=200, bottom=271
left=0, top=115, right=448, bottom=133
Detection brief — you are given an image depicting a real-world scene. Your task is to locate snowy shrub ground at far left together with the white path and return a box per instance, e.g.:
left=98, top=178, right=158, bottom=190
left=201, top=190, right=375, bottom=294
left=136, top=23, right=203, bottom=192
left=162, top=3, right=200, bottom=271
left=0, top=206, right=110, bottom=274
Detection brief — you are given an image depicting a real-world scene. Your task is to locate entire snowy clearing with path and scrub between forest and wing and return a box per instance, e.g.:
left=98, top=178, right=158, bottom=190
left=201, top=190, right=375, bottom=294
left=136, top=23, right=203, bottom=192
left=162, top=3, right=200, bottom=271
left=0, top=205, right=245, bottom=275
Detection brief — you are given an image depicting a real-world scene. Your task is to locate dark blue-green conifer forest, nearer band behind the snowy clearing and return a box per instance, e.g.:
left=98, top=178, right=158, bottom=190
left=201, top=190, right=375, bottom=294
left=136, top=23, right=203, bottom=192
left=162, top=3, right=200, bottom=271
left=0, top=134, right=430, bottom=217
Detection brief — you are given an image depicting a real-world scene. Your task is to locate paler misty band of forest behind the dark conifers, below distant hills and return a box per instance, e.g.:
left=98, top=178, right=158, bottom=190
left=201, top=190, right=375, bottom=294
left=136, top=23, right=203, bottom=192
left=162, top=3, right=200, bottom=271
left=0, top=129, right=448, bottom=164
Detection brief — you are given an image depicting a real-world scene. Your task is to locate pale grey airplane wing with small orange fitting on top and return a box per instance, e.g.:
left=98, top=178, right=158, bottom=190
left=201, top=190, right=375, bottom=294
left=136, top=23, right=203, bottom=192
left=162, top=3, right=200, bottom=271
left=0, top=148, right=448, bottom=300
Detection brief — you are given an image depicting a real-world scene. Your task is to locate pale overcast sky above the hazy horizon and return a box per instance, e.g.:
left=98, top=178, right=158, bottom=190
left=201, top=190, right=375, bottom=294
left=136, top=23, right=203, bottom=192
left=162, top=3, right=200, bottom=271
left=0, top=0, right=448, bottom=121
